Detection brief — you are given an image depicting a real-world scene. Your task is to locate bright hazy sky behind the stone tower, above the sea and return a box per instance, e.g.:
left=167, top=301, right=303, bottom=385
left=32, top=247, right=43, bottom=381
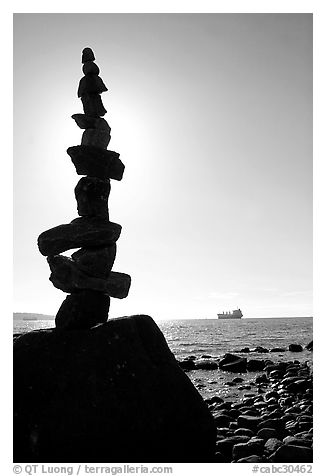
left=14, top=13, right=312, bottom=319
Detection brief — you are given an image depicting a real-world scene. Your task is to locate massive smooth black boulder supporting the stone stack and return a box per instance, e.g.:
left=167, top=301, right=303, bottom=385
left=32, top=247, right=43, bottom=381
left=14, top=315, right=216, bottom=463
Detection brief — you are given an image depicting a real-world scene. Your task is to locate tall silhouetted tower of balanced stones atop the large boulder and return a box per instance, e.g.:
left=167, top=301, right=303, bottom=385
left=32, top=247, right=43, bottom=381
left=38, top=48, right=131, bottom=329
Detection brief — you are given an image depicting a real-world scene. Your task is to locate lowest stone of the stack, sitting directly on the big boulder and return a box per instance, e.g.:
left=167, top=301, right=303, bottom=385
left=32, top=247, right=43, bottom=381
left=55, top=290, right=110, bottom=329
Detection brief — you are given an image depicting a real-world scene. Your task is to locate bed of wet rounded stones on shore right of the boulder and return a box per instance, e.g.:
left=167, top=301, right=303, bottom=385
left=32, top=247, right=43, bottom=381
left=204, top=361, right=313, bottom=463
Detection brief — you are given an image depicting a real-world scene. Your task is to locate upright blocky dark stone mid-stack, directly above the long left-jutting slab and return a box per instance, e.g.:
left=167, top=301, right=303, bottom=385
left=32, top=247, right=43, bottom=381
left=75, top=177, right=111, bottom=217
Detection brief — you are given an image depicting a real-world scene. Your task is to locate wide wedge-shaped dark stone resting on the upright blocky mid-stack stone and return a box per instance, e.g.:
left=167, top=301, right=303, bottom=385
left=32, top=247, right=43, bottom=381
left=67, top=145, right=125, bottom=180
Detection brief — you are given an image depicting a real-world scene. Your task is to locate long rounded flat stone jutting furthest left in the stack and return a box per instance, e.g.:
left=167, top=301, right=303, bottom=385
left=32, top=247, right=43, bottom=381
left=38, top=217, right=121, bottom=256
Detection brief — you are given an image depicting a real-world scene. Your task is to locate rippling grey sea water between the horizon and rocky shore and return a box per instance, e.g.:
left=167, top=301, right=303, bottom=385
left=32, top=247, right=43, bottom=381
left=14, top=317, right=313, bottom=400
